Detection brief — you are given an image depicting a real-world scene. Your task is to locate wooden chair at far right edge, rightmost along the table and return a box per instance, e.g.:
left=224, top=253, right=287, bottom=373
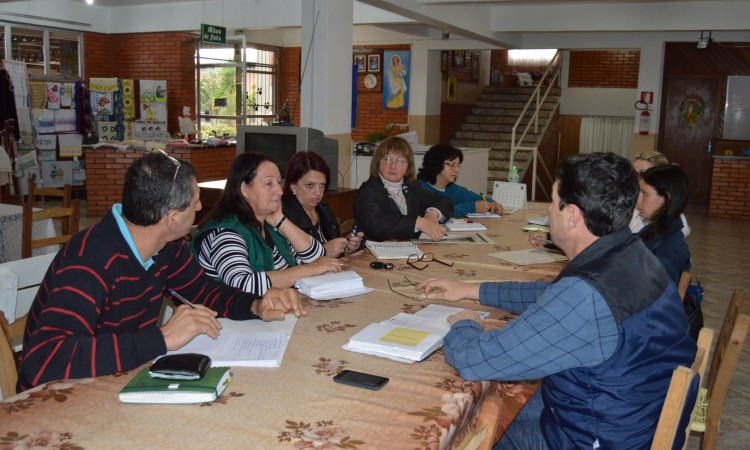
left=690, top=289, right=750, bottom=450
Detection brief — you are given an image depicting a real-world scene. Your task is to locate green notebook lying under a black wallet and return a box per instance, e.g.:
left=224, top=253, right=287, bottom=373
left=120, top=367, right=232, bottom=403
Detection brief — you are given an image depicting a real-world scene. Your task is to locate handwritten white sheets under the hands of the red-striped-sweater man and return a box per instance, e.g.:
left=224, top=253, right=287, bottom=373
left=167, top=314, right=297, bottom=367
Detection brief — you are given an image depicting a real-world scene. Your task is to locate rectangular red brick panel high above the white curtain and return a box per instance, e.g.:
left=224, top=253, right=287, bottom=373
left=568, top=50, right=641, bottom=89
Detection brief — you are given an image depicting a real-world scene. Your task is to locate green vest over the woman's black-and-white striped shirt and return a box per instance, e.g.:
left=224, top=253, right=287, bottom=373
left=190, top=214, right=297, bottom=272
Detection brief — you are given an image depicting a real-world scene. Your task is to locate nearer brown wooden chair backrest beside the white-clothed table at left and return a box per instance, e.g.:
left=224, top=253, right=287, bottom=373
left=21, top=200, right=81, bottom=258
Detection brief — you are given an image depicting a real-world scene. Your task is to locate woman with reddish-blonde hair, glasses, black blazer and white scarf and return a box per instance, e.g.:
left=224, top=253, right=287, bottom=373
left=354, top=137, right=453, bottom=241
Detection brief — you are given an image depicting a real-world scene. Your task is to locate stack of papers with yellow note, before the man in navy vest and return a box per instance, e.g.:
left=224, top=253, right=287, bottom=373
left=344, top=305, right=488, bottom=362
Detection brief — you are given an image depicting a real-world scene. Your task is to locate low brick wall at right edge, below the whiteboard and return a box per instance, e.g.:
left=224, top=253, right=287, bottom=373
left=708, top=158, right=750, bottom=220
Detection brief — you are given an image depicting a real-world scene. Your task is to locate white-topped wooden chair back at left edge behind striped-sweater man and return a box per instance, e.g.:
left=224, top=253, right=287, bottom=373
left=0, top=254, right=55, bottom=398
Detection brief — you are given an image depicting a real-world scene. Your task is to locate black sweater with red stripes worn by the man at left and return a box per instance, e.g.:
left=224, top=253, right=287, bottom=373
left=18, top=211, right=258, bottom=391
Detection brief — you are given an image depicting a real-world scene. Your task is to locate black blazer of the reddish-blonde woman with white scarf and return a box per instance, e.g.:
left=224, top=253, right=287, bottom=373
left=354, top=176, right=453, bottom=241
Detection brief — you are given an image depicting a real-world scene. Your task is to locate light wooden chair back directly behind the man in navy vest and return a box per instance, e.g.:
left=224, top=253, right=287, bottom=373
left=651, top=328, right=714, bottom=450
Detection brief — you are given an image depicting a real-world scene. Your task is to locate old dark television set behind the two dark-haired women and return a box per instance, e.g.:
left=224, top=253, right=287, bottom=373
left=237, top=125, right=339, bottom=189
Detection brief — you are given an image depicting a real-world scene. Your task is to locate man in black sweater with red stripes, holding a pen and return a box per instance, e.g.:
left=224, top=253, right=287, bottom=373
left=17, top=152, right=305, bottom=392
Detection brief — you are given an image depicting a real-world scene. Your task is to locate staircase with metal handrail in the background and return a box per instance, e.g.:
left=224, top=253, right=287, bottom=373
left=450, top=86, right=560, bottom=198
